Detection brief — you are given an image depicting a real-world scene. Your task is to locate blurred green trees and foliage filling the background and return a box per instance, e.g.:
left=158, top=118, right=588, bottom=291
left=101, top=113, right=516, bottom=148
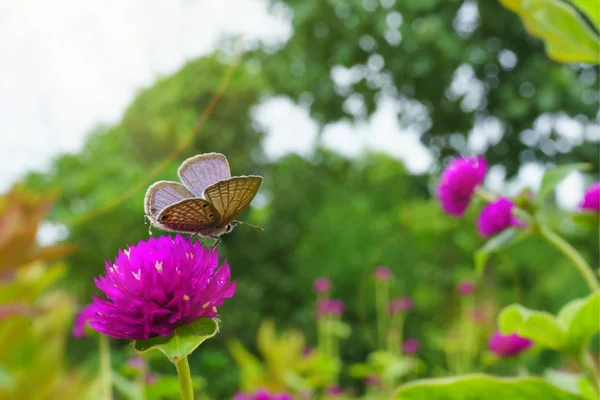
left=0, top=0, right=600, bottom=399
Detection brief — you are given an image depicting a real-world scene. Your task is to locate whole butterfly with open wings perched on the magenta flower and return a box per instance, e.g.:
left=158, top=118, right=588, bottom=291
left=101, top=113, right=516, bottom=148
left=144, top=153, right=262, bottom=246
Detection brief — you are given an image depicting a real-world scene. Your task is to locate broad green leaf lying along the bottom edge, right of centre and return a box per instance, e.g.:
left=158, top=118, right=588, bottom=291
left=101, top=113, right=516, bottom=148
left=394, top=374, right=582, bottom=400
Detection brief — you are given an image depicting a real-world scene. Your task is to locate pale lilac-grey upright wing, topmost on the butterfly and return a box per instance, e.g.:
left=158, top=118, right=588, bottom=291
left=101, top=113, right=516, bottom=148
left=177, top=153, right=231, bottom=197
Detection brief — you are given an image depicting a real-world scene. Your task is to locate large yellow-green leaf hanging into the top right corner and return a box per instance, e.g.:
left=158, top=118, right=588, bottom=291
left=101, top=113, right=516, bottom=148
left=500, top=0, right=600, bottom=63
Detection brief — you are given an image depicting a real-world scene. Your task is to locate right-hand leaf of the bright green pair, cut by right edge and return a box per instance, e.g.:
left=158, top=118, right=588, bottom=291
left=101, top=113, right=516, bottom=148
left=558, top=291, right=600, bottom=351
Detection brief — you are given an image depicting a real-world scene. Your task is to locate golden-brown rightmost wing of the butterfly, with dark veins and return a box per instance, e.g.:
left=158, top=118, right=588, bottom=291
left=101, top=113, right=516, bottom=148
left=204, top=175, right=262, bottom=226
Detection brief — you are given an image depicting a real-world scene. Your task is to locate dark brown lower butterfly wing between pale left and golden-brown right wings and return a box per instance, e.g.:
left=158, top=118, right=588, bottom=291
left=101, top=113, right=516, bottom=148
left=156, top=198, right=221, bottom=235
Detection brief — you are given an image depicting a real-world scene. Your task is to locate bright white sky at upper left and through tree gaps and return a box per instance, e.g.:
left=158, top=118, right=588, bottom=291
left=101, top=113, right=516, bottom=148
left=0, top=0, right=583, bottom=216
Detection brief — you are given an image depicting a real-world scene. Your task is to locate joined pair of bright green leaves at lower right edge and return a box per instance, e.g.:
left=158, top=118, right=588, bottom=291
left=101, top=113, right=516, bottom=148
left=498, top=292, right=600, bottom=357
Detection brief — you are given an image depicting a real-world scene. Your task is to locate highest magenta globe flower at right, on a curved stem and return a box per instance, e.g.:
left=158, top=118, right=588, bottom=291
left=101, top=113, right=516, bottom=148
left=437, top=157, right=487, bottom=217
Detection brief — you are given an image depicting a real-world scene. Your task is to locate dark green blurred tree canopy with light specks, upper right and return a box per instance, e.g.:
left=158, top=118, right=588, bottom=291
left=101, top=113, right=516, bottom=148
left=255, top=0, right=598, bottom=177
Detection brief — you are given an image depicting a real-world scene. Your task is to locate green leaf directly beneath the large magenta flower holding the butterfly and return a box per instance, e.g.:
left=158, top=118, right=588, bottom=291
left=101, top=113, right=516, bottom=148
left=134, top=318, right=219, bottom=363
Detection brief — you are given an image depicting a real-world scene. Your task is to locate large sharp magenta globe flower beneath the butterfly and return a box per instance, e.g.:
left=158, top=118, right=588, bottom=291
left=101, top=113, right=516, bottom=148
left=90, top=235, right=235, bottom=340
